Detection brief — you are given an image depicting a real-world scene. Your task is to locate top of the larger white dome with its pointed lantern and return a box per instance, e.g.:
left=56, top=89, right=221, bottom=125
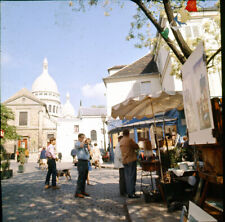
left=32, top=58, right=59, bottom=94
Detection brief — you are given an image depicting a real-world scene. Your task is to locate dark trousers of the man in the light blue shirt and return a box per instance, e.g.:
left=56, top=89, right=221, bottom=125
left=76, top=160, right=88, bottom=194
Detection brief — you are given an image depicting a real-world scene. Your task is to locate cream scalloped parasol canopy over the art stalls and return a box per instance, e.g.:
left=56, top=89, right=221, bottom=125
left=111, top=91, right=183, bottom=120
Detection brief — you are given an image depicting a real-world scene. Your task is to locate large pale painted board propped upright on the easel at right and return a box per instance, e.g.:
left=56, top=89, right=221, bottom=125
left=181, top=42, right=216, bottom=145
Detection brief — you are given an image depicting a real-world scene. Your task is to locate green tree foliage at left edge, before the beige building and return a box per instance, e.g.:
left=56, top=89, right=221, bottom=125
left=1, top=104, right=20, bottom=143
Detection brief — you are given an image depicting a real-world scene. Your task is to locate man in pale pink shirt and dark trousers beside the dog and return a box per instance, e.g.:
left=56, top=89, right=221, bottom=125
left=45, top=137, right=60, bottom=189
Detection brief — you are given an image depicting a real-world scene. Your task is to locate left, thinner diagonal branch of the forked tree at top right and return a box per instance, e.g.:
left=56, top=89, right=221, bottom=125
left=131, top=0, right=186, bottom=64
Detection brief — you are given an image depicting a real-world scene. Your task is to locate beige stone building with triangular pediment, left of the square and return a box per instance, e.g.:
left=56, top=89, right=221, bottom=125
left=3, top=88, right=56, bottom=152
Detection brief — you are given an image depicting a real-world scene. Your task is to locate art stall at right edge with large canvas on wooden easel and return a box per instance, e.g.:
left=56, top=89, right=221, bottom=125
left=182, top=43, right=223, bottom=221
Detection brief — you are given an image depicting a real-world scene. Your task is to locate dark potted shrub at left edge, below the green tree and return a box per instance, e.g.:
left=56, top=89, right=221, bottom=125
left=0, top=145, right=13, bottom=180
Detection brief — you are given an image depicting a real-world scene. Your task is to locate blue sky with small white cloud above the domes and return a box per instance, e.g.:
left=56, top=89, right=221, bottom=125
left=1, top=1, right=149, bottom=112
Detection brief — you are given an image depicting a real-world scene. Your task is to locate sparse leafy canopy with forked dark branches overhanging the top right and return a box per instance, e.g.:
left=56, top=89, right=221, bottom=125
left=69, top=0, right=221, bottom=68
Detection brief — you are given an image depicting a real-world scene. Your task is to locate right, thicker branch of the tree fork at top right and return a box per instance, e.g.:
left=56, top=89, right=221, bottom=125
left=163, top=0, right=192, bottom=58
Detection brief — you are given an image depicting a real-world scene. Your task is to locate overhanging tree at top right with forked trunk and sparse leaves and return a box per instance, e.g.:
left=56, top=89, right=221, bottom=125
left=70, top=0, right=221, bottom=67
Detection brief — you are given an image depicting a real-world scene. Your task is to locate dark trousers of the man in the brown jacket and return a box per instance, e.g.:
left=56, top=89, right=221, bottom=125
left=124, top=161, right=137, bottom=195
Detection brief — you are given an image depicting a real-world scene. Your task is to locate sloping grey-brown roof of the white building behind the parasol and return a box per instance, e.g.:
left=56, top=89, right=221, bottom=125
left=104, top=53, right=159, bottom=80
